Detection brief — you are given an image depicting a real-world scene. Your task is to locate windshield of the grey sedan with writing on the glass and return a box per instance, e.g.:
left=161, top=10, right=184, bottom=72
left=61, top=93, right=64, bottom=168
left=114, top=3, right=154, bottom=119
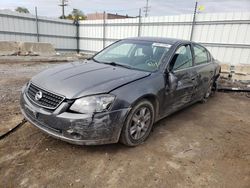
left=94, top=40, right=171, bottom=72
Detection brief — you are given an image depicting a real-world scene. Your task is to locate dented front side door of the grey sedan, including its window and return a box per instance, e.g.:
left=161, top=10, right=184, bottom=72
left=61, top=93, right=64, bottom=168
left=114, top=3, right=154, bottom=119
left=164, top=44, right=197, bottom=115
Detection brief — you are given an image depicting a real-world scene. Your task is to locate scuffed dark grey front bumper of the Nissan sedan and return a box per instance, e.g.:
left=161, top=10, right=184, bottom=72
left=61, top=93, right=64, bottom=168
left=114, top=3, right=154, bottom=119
left=20, top=88, right=129, bottom=145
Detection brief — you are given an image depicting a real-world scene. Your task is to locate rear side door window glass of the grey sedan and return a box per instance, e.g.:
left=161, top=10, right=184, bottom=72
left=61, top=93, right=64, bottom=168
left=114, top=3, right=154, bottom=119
left=194, top=45, right=208, bottom=65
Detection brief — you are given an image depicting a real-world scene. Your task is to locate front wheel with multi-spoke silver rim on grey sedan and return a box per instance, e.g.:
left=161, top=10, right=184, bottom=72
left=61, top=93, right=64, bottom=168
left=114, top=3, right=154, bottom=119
left=120, top=100, right=155, bottom=146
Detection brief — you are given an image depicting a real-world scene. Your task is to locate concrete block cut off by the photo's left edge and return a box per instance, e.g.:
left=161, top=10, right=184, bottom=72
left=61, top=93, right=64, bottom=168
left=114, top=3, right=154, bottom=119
left=0, top=41, right=19, bottom=56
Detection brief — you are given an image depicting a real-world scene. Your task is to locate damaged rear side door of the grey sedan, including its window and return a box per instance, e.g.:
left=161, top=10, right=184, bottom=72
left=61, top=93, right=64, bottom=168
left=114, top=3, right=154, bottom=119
left=192, top=44, right=214, bottom=100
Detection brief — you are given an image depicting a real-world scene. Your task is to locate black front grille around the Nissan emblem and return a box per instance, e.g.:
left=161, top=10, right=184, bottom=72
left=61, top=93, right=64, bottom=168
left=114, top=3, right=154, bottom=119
left=27, top=83, right=64, bottom=109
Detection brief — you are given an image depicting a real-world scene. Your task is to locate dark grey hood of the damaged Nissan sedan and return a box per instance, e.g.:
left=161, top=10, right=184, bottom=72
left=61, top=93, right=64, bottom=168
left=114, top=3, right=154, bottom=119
left=31, top=60, right=150, bottom=99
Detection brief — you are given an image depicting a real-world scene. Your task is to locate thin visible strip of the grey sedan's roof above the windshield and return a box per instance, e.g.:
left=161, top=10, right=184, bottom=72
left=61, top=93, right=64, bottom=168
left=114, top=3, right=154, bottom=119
left=125, top=37, right=190, bottom=45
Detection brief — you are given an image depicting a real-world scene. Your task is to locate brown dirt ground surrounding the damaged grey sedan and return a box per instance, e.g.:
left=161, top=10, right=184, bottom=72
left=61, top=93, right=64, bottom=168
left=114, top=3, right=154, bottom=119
left=0, top=63, right=250, bottom=188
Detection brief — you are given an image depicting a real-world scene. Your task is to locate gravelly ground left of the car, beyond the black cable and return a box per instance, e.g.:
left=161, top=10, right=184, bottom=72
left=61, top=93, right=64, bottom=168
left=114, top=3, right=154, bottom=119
left=0, top=62, right=58, bottom=136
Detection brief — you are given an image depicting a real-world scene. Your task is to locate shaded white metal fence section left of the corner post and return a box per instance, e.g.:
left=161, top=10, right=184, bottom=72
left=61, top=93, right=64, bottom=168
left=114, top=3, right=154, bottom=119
left=0, top=10, right=77, bottom=51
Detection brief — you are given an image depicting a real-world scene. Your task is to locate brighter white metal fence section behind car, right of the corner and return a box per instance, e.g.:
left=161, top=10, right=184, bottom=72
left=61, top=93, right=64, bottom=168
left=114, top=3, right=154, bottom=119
left=80, top=12, right=250, bottom=65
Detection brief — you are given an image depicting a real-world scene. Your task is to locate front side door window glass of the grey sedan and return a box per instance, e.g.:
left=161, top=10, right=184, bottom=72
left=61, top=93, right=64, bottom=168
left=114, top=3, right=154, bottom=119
left=170, top=45, right=192, bottom=70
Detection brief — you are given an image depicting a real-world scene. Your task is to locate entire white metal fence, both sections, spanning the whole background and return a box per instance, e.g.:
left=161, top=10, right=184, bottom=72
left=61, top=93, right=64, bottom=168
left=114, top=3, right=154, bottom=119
left=0, top=10, right=250, bottom=65
